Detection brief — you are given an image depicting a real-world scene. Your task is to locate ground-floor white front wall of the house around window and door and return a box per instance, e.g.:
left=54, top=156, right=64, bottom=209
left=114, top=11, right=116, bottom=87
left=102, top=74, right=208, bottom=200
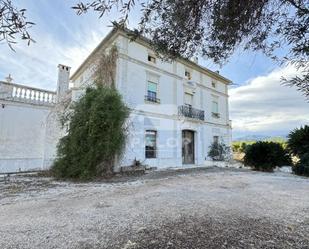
left=118, top=113, right=230, bottom=169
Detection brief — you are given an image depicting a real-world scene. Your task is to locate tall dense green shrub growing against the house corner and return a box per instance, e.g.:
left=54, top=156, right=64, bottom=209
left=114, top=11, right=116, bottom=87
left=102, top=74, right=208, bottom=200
left=52, top=86, right=128, bottom=179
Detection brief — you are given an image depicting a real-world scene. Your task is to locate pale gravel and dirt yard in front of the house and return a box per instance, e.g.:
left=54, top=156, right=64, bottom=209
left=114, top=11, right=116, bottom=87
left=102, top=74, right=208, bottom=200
left=0, top=168, right=309, bottom=249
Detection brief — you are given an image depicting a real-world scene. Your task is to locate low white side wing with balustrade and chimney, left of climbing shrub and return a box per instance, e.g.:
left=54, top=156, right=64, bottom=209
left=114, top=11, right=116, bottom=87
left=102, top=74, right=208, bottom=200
left=0, top=65, right=70, bottom=173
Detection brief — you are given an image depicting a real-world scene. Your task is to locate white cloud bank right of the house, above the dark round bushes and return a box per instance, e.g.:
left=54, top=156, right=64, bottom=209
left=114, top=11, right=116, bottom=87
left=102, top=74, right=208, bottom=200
left=230, top=66, right=309, bottom=135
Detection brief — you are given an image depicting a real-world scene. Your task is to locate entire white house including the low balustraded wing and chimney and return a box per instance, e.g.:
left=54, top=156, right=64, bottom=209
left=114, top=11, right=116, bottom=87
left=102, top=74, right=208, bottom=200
left=0, top=28, right=231, bottom=172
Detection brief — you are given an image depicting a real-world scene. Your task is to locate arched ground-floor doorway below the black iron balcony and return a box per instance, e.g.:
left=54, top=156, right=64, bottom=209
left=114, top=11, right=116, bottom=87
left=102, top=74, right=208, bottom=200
left=182, top=130, right=195, bottom=164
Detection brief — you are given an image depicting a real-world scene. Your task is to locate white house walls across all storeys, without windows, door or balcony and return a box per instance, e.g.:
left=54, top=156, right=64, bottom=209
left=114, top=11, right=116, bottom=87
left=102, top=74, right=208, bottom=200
left=74, top=32, right=231, bottom=169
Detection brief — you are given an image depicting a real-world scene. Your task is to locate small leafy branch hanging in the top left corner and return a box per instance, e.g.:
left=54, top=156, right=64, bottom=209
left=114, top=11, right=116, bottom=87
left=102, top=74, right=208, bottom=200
left=0, top=0, right=34, bottom=50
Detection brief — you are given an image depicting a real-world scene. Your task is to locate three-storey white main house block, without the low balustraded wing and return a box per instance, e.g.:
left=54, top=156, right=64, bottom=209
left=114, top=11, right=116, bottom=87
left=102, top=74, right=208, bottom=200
left=70, top=29, right=231, bottom=171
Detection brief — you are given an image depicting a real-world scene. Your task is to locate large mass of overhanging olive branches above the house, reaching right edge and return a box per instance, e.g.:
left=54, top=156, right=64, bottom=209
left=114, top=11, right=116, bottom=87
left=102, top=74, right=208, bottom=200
left=73, top=0, right=309, bottom=98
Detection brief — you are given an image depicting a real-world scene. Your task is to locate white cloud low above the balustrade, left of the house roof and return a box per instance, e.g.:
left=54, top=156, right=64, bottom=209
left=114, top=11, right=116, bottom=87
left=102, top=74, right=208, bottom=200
left=0, top=29, right=104, bottom=90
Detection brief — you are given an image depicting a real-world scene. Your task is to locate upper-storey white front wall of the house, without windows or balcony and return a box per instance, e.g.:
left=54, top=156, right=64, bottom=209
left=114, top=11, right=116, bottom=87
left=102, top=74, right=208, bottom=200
left=113, top=34, right=229, bottom=125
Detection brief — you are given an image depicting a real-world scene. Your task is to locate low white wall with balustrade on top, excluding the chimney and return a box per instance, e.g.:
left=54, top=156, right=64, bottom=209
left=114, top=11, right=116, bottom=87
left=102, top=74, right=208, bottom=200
left=0, top=81, right=56, bottom=172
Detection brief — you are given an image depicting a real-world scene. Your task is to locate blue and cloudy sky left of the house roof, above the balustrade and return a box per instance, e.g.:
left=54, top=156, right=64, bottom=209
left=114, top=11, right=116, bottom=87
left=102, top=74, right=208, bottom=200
left=0, top=0, right=114, bottom=90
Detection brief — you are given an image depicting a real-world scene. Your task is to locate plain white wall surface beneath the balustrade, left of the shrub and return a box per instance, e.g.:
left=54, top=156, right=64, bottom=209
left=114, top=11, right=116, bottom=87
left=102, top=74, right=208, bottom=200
left=0, top=100, right=50, bottom=172
